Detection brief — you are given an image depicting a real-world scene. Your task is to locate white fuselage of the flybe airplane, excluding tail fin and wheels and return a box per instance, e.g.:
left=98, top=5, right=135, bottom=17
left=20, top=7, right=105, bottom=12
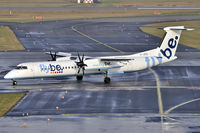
left=4, top=49, right=177, bottom=80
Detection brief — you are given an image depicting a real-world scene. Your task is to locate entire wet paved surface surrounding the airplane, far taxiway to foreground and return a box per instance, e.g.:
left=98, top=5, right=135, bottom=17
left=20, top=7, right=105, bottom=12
left=0, top=16, right=200, bottom=132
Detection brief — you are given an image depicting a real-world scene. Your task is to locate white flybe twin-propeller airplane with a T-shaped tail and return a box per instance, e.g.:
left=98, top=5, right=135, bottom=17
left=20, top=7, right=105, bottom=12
left=4, top=26, right=193, bottom=85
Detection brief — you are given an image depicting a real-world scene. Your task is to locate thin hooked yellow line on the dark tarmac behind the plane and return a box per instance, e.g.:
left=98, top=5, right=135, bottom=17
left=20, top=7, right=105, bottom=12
left=71, top=23, right=122, bottom=53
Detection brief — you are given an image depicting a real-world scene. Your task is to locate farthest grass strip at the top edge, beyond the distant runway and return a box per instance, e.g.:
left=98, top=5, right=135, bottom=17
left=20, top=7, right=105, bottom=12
left=0, top=0, right=200, bottom=7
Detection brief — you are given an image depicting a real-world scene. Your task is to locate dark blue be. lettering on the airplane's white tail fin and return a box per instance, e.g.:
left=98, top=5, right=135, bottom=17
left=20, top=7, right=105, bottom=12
left=160, top=36, right=178, bottom=59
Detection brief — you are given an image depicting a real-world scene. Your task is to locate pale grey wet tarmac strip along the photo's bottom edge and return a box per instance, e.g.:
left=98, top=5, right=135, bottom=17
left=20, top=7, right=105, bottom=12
left=0, top=114, right=200, bottom=133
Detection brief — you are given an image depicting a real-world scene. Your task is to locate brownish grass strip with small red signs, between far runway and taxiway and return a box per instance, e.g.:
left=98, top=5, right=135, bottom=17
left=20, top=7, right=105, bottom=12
left=0, top=10, right=200, bottom=22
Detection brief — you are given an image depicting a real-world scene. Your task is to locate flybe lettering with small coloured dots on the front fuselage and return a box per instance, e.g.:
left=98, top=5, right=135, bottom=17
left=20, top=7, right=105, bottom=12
left=40, top=64, right=64, bottom=74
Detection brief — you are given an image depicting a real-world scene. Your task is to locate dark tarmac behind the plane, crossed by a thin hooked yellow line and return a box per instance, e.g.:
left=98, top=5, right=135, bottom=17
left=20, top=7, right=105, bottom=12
left=0, top=15, right=200, bottom=52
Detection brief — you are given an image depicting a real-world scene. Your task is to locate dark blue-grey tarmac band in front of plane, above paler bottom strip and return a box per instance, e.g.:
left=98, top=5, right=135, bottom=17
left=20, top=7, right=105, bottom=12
left=3, top=86, right=200, bottom=116
